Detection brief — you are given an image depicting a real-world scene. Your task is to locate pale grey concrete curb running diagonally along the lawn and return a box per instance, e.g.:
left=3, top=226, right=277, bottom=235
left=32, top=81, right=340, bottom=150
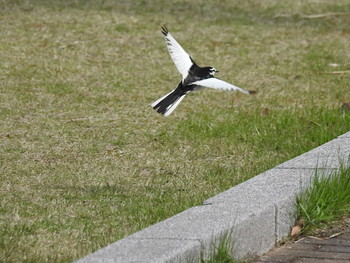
left=76, top=132, right=350, bottom=263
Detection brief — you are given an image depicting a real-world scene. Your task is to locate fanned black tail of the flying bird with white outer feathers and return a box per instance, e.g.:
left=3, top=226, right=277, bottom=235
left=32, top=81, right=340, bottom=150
left=151, top=89, right=186, bottom=116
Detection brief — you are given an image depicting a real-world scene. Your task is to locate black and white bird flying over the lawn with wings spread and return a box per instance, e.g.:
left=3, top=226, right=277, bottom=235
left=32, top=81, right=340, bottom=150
left=151, top=26, right=249, bottom=116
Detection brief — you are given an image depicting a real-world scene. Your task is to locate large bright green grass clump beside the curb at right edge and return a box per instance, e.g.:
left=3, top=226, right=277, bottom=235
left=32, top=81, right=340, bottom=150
left=297, top=167, right=350, bottom=233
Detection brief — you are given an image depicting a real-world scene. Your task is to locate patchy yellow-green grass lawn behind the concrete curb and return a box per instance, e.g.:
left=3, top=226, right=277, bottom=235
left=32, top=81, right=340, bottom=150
left=0, top=0, right=350, bottom=262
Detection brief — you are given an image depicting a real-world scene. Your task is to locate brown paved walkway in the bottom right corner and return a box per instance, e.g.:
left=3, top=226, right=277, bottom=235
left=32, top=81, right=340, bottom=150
left=254, top=225, right=350, bottom=263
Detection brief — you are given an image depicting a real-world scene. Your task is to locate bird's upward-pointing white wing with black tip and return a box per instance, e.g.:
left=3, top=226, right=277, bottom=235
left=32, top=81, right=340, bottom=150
left=162, top=26, right=194, bottom=79
